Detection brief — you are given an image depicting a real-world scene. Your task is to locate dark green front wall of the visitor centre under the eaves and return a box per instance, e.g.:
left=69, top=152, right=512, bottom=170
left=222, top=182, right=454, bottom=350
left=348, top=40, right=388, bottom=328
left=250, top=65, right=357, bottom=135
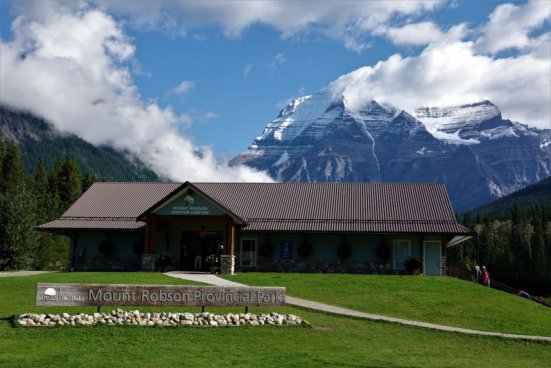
left=69, top=229, right=446, bottom=273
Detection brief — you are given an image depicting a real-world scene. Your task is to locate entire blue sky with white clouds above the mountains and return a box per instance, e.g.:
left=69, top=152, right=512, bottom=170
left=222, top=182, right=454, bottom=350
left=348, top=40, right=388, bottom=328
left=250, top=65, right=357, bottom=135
left=0, top=0, right=551, bottom=181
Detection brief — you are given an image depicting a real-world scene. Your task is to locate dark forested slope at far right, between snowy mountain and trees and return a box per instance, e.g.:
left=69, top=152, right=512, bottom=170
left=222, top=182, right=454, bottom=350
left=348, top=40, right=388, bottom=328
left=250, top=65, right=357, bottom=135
left=473, top=176, right=551, bottom=213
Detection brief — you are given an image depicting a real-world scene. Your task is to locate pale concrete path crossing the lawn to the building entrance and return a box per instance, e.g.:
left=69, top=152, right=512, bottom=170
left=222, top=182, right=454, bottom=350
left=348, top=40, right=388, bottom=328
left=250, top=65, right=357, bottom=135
left=165, top=271, right=551, bottom=342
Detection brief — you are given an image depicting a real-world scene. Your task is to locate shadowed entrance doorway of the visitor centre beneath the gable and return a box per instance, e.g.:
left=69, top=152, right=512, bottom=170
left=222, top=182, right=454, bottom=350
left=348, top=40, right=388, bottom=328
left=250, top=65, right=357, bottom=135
left=179, top=227, right=224, bottom=271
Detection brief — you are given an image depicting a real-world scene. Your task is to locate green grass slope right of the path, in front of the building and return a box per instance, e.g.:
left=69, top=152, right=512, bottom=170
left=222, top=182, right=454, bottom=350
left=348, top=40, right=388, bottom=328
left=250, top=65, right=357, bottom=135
left=221, top=273, right=551, bottom=336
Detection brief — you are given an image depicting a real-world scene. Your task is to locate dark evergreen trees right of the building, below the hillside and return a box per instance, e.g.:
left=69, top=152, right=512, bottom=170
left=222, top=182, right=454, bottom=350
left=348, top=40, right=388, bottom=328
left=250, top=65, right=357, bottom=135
left=448, top=203, right=551, bottom=296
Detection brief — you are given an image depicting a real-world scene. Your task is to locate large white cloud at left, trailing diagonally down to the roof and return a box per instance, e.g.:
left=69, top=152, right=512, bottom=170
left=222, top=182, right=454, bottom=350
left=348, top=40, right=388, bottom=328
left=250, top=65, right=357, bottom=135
left=0, top=2, right=270, bottom=181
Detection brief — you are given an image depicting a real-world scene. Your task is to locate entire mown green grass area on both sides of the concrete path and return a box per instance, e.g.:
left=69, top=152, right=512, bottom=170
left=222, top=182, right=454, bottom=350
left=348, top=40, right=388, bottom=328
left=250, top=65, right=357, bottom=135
left=0, top=272, right=550, bottom=368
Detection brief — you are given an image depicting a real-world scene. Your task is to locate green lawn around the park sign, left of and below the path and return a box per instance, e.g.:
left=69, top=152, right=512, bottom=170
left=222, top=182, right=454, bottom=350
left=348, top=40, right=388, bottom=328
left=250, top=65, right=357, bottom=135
left=0, top=273, right=551, bottom=368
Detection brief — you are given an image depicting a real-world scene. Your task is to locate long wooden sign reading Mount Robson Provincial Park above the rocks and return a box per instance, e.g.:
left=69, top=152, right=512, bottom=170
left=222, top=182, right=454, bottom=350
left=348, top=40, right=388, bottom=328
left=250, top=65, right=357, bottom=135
left=36, top=283, right=285, bottom=307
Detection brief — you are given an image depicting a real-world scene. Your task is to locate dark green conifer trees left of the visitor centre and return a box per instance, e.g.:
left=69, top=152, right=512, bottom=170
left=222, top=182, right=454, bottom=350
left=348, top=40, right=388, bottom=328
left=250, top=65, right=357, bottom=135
left=0, top=140, right=96, bottom=270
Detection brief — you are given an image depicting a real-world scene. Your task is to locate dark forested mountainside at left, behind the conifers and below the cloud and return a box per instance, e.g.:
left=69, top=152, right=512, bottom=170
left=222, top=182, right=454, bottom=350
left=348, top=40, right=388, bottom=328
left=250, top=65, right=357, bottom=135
left=0, top=106, right=159, bottom=181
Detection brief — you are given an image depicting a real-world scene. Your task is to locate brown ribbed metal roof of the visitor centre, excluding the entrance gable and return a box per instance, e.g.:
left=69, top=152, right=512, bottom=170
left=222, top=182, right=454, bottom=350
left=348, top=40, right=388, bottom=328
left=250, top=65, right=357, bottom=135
left=37, top=183, right=470, bottom=234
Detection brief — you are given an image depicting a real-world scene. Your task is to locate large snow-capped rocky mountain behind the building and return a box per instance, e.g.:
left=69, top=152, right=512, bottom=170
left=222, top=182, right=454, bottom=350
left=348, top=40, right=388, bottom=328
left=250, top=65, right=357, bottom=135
left=232, top=90, right=551, bottom=211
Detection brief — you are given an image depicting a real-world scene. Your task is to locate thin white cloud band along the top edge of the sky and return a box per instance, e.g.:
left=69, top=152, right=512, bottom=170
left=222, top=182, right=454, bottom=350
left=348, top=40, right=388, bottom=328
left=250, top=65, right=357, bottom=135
left=76, top=0, right=444, bottom=51
